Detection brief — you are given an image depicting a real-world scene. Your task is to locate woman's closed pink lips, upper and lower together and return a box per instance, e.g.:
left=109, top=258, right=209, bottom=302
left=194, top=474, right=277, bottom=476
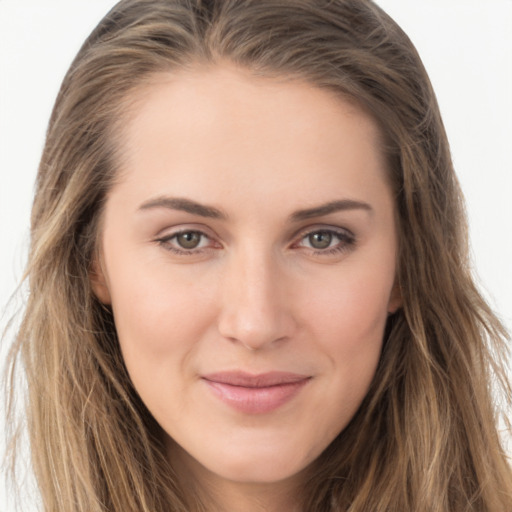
left=202, top=372, right=311, bottom=414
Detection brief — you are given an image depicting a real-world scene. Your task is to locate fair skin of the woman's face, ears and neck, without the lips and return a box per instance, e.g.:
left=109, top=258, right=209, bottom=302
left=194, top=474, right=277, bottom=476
left=93, top=65, right=400, bottom=511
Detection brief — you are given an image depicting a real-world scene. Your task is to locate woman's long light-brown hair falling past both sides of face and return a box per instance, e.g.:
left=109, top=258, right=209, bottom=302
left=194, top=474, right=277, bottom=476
left=5, top=0, right=512, bottom=512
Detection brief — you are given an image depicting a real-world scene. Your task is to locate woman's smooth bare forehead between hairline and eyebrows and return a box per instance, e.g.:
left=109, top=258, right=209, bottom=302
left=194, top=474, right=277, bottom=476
left=111, top=66, right=392, bottom=216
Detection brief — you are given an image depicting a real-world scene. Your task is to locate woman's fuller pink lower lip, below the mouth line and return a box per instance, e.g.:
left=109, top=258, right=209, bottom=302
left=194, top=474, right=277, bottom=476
left=205, top=379, right=309, bottom=414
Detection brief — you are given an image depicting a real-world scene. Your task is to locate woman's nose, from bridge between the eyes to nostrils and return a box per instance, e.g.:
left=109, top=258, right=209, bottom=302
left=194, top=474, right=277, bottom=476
left=218, top=251, right=296, bottom=350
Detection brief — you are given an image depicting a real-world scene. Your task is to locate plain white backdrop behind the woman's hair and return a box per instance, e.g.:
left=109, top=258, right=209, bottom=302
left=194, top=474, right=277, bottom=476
left=0, top=0, right=512, bottom=512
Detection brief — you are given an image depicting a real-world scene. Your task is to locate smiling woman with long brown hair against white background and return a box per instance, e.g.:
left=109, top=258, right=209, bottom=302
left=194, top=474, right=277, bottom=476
left=5, top=0, right=512, bottom=511
